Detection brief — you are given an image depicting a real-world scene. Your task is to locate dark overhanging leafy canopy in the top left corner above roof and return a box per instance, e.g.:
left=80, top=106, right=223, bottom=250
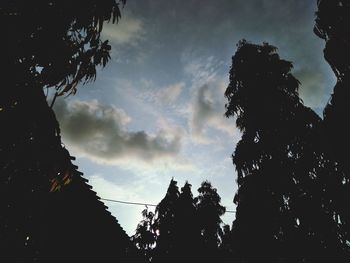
left=0, top=0, right=125, bottom=98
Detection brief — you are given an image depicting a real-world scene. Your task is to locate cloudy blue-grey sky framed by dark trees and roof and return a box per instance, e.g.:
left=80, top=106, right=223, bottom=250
left=54, top=0, right=335, bottom=235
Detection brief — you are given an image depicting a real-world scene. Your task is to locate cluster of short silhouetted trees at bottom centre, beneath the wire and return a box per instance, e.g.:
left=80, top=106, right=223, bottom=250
left=132, top=179, right=227, bottom=263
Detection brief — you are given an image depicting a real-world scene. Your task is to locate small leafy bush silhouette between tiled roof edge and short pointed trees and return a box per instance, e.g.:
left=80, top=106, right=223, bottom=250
left=131, top=208, right=156, bottom=262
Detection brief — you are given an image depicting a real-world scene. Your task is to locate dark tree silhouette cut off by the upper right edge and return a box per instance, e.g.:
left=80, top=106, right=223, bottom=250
left=314, top=0, right=350, bottom=171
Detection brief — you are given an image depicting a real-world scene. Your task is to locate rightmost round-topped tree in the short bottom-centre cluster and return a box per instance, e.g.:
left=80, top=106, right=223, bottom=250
left=195, top=181, right=226, bottom=262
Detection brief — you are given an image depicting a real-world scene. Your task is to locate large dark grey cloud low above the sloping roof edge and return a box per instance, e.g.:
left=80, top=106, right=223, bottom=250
left=55, top=100, right=183, bottom=164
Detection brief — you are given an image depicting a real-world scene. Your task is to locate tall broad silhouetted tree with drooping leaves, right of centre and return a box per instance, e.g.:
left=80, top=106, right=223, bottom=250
left=225, top=41, right=342, bottom=262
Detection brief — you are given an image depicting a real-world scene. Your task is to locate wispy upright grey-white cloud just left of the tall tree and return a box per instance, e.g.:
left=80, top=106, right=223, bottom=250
left=182, top=54, right=237, bottom=144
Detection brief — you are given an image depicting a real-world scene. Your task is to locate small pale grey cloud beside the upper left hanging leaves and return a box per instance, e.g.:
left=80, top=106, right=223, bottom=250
left=102, top=14, right=145, bottom=45
